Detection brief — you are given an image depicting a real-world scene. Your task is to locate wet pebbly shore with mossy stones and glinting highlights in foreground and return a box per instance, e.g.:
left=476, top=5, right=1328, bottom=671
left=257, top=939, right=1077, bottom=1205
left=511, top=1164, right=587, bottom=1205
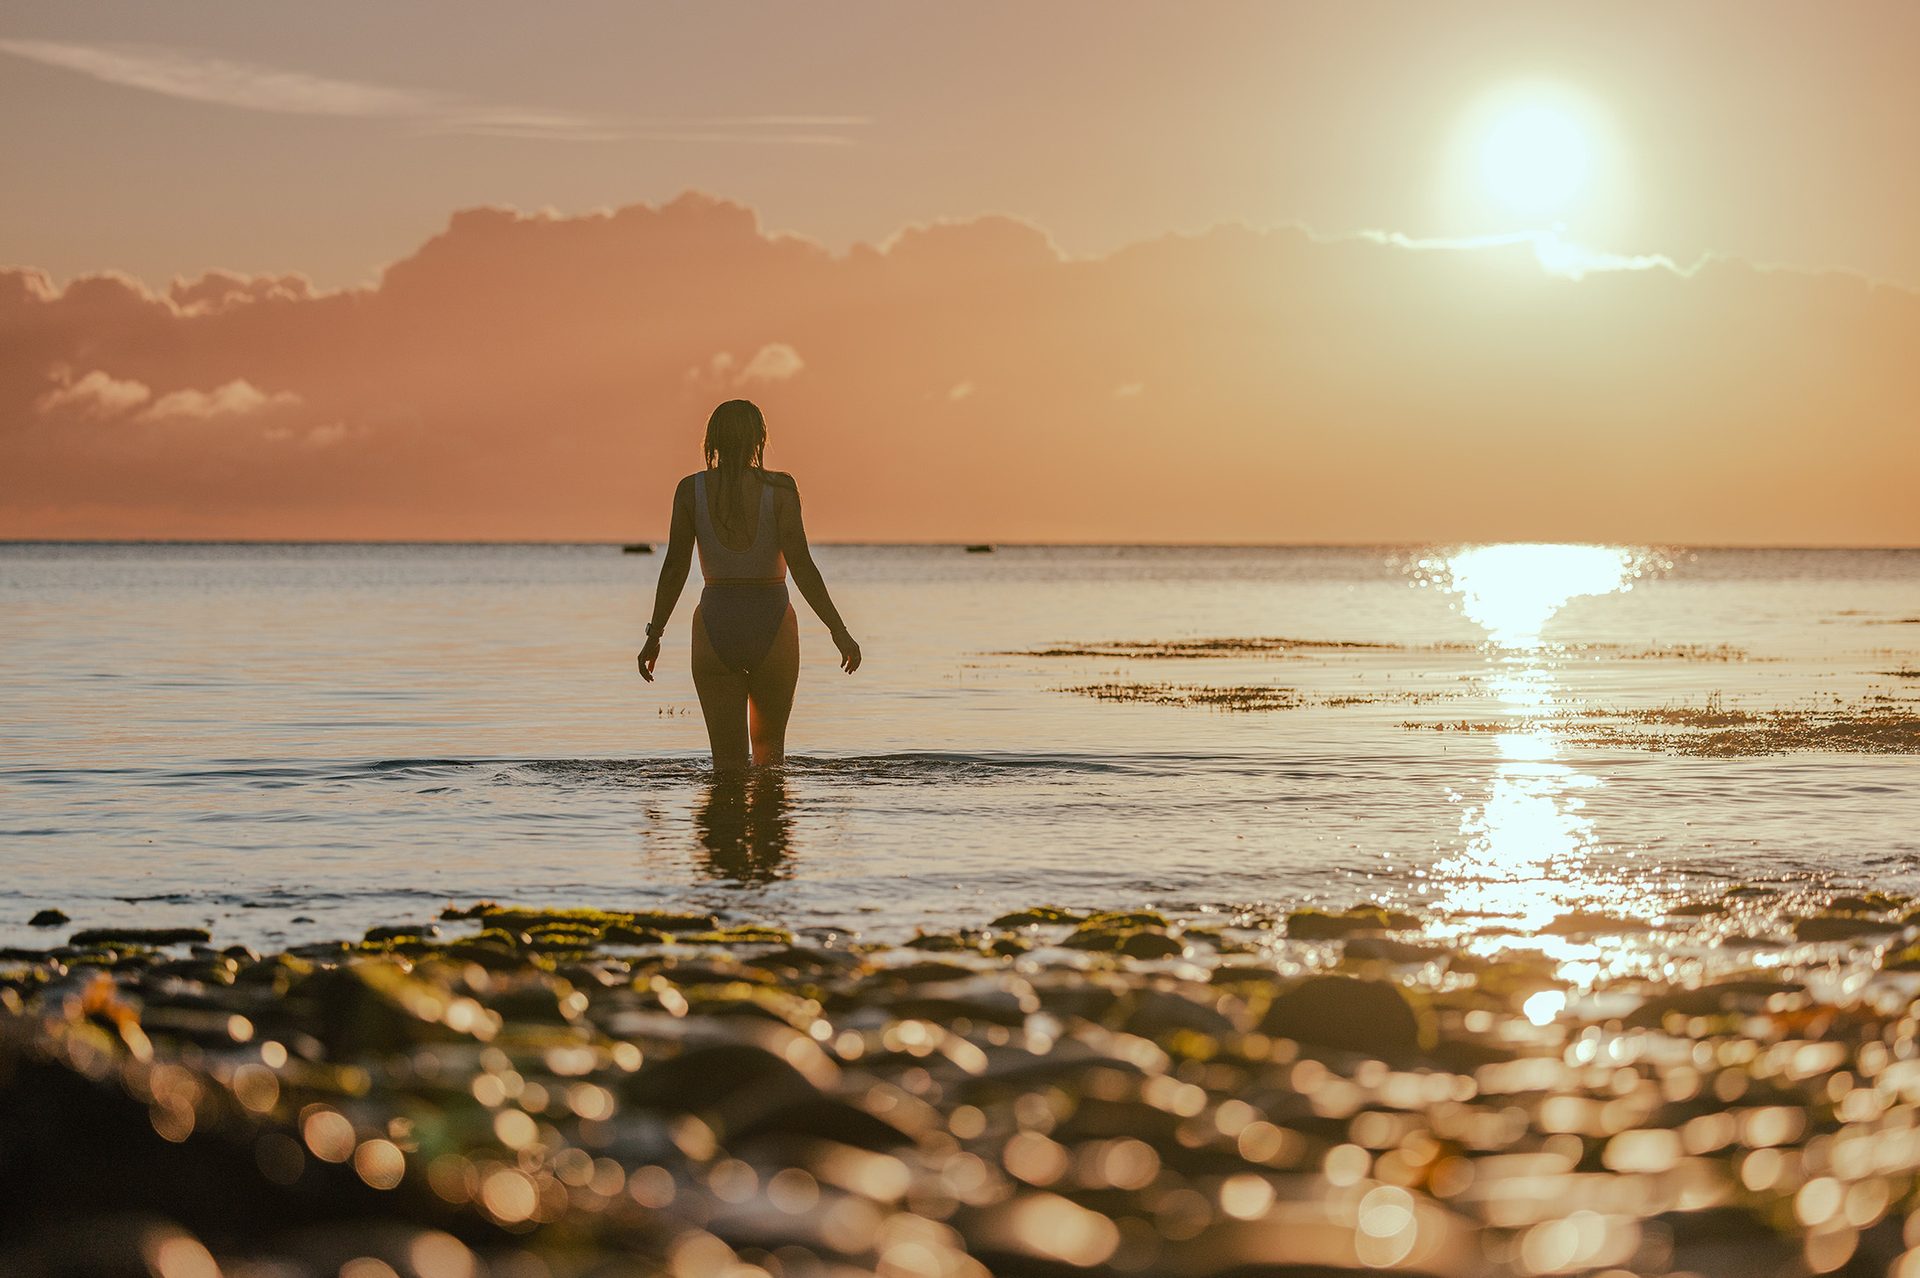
left=0, top=901, right=1920, bottom=1278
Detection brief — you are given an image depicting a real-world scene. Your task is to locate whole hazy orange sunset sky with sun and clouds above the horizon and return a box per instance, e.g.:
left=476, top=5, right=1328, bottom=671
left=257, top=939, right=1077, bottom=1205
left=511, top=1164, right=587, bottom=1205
left=0, top=0, right=1920, bottom=545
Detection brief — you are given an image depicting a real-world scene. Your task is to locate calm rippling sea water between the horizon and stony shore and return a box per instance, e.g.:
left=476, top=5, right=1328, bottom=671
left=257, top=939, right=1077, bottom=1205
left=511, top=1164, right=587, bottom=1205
left=0, top=545, right=1920, bottom=944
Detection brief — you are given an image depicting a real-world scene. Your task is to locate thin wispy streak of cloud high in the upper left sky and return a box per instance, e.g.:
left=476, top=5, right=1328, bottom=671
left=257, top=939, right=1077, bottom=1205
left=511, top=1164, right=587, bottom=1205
left=0, top=38, right=870, bottom=146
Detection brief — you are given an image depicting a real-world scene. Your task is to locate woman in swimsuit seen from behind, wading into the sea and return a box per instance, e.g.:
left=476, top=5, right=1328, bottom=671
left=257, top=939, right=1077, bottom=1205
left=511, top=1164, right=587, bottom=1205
left=639, top=399, right=860, bottom=771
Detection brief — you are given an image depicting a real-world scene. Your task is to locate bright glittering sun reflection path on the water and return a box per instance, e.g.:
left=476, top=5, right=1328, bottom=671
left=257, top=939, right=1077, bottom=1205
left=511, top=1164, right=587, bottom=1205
left=1419, top=545, right=1657, bottom=955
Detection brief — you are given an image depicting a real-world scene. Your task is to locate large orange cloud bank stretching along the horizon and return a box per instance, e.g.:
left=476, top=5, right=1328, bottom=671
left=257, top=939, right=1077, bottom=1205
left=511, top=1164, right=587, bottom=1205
left=0, top=194, right=1920, bottom=545
